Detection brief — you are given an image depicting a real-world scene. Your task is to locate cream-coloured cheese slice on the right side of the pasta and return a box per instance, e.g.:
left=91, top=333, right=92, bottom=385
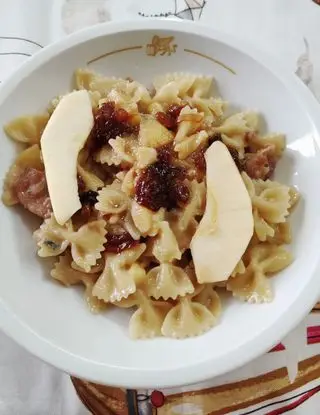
left=191, top=141, right=253, bottom=283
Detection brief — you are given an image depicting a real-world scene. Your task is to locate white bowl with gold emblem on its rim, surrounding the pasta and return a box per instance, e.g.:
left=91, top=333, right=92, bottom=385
left=0, top=20, right=320, bottom=388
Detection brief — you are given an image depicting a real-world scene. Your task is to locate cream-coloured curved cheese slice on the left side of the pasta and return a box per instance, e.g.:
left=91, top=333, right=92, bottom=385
left=41, top=90, right=94, bottom=225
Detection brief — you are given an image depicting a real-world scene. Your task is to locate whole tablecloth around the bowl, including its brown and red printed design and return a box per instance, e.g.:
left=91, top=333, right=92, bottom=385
left=0, top=0, right=320, bottom=415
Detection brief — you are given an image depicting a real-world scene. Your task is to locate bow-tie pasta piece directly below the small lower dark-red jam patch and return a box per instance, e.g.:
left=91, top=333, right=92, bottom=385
left=93, top=244, right=146, bottom=303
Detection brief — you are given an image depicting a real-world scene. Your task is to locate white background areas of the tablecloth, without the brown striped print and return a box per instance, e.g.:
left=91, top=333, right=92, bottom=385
left=0, top=0, right=320, bottom=415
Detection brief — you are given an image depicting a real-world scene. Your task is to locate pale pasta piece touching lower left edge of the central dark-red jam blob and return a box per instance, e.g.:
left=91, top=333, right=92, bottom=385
left=131, top=200, right=165, bottom=236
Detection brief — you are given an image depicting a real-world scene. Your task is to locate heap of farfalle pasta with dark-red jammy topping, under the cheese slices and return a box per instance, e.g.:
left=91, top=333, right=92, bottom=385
left=2, top=68, right=300, bottom=339
